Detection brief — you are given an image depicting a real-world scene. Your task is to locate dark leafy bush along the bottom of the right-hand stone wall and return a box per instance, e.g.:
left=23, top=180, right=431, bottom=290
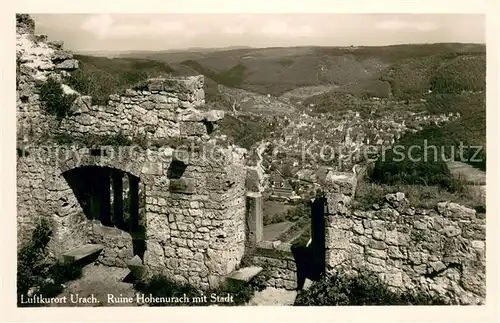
left=294, top=273, right=448, bottom=306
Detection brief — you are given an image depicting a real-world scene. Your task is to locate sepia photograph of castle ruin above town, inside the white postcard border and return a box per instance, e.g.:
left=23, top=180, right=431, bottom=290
left=9, top=5, right=487, bottom=316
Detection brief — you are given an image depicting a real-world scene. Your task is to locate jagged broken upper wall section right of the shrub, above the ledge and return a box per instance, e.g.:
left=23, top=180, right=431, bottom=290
left=60, top=75, right=218, bottom=141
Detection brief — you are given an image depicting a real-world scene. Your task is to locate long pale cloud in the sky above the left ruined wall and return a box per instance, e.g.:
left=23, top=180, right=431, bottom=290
left=80, top=14, right=189, bottom=39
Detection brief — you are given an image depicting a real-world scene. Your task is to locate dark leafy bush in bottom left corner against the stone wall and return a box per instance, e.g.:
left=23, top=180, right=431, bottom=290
left=17, top=218, right=82, bottom=307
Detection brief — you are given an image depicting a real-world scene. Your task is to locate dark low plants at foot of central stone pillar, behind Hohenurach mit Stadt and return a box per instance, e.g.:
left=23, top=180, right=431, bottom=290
left=134, top=275, right=258, bottom=306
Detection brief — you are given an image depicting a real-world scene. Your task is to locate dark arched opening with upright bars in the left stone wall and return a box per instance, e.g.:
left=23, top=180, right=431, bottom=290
left=63, top=166, right=146, bottom=258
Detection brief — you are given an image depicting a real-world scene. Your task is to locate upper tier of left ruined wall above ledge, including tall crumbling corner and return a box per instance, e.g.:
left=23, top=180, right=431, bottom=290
left=16, top=15, right=224, bottom=141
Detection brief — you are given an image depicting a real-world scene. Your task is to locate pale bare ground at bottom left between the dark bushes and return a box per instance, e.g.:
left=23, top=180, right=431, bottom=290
left=51, top=264, right=137, bottom=307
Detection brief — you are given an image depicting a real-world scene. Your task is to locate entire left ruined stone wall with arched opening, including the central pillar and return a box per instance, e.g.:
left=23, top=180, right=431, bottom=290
left=16, top=15, right=246, bottom=287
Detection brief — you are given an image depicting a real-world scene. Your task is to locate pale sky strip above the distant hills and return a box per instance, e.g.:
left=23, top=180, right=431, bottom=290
left=32, top=13, right=486, bottom=51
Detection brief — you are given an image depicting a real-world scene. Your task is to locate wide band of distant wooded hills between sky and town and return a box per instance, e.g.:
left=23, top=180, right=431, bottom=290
left=73, top=44, right=485, bottom=109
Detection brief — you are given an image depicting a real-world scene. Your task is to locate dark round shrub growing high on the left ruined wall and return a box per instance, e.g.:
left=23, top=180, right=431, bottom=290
left=38, top=77, right=77, bottom=121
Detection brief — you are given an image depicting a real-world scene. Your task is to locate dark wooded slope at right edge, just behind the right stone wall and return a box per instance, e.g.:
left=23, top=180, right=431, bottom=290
left=370, top=93, right=486, bottom=191
